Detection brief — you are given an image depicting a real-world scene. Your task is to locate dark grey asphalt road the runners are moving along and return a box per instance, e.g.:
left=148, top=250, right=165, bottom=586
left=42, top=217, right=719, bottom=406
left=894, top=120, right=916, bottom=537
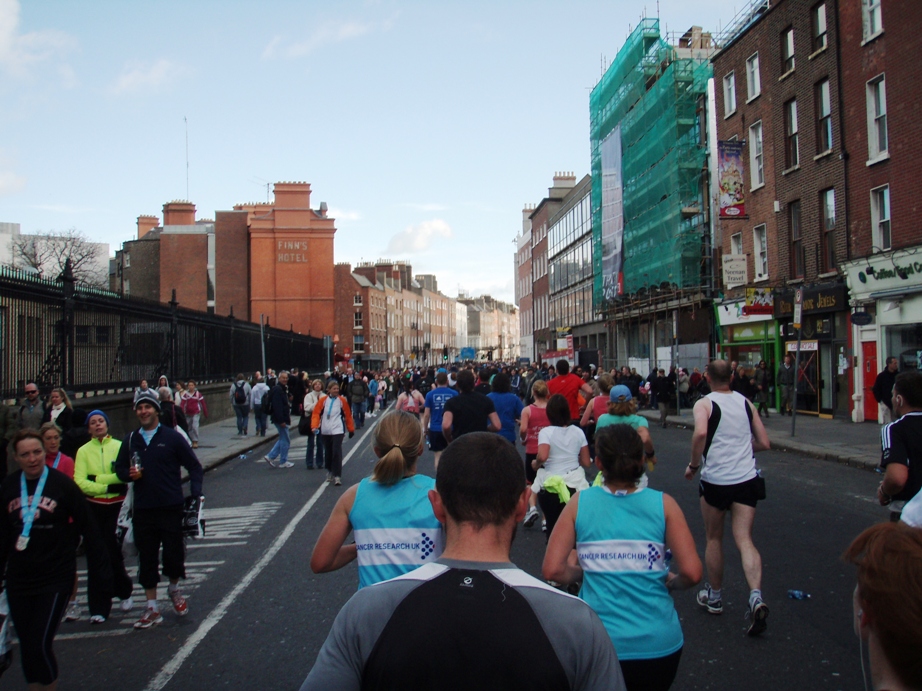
left=0, top=420, right=886, bottom=691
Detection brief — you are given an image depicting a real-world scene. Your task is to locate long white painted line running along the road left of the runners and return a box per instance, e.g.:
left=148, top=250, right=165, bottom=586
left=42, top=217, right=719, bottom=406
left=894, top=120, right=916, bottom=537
left=145, top=421, right=377, bottom=691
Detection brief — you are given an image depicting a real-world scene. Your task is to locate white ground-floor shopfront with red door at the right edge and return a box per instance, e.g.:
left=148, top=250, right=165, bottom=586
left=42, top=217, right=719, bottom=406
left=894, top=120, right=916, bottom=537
left=843, top=246, right=922, bottom=422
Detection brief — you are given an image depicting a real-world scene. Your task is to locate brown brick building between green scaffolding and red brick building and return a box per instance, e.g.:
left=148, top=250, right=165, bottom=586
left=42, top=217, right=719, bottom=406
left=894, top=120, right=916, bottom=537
left=712, top=0, right=858, bottom=415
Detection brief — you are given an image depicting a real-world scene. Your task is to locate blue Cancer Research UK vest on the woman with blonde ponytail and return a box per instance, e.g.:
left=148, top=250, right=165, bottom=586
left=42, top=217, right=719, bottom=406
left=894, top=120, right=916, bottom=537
left=349, top=475, right=445, bottom=589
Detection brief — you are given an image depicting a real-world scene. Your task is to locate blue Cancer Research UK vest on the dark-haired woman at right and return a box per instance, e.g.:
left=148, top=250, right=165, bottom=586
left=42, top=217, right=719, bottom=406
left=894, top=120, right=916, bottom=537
left=576, top=487, right=684, bottom=660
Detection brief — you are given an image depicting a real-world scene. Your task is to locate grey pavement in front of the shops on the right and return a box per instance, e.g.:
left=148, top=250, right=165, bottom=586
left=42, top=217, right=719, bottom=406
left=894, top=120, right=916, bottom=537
left=640, top=408, right=880, bottom=470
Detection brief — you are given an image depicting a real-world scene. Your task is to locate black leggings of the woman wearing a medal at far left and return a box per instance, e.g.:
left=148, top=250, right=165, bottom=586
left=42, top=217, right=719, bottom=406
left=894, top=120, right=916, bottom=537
left=7, top=582, right=73, bottom=686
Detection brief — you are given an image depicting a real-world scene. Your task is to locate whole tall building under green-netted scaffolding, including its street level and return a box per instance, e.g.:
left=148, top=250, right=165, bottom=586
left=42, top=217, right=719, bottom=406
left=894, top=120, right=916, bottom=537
left=590, top=19, right=714, bottom=374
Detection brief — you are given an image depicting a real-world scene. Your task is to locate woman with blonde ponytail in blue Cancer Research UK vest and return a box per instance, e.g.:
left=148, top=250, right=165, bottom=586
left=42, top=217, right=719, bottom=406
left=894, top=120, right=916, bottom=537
left=311, top=411, right=443, bottom=588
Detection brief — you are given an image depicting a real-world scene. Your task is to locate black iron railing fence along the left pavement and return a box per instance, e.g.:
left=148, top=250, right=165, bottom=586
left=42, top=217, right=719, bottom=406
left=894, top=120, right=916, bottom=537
left=0, top=267, right=326, bottom=399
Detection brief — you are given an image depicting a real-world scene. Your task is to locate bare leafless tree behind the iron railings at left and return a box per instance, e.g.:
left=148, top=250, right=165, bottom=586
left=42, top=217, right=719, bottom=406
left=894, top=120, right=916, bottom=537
left=11, top=228, right=108, bottom=288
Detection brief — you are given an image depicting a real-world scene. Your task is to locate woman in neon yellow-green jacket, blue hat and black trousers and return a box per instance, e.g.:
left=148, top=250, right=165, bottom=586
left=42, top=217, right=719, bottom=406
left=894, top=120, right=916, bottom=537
left=74, top=410, right=134, bottom=624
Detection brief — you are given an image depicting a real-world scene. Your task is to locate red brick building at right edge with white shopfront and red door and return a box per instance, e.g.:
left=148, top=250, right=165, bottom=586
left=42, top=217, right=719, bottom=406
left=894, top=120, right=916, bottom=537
left=837, top=0, right=922, bottom=422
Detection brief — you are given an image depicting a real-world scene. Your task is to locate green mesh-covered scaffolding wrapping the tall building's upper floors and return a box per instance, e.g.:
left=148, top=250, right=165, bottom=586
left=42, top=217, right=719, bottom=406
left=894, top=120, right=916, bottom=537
left=589, top=19, right=714, bottom=311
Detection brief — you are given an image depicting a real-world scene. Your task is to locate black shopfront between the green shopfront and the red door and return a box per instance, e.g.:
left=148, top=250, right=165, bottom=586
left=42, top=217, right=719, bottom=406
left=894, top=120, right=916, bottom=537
left=775, top=283, right=853, bottom=417
